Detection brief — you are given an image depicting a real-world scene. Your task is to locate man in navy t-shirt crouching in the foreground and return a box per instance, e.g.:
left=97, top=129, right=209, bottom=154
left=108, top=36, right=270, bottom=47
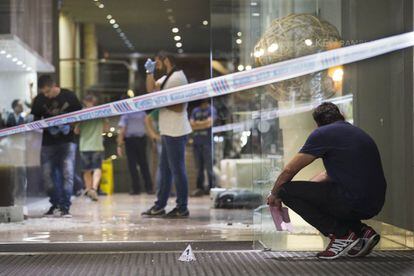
left=268, top=103, right=386, bottom=259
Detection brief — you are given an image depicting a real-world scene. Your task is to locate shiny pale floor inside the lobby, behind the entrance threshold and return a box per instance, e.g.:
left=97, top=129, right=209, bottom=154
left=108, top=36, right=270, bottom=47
left=0, top=194, right=413, bottom=251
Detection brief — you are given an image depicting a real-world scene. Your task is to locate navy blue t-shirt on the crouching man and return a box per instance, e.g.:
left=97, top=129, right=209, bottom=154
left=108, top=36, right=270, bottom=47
left=300, top=121, right=387, bottom=213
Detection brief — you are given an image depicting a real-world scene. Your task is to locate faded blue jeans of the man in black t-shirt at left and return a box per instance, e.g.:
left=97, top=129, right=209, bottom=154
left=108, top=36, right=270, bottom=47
left=41, top=143, right=76, bottom=210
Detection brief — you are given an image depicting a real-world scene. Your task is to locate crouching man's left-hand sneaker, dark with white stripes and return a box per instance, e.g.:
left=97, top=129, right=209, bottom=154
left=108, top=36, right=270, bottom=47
left=316, top=232, right=359, bottom=260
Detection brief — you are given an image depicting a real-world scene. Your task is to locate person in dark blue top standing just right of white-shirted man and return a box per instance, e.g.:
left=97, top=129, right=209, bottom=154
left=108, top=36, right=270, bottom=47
left=190, top=99, right=216, bottom=196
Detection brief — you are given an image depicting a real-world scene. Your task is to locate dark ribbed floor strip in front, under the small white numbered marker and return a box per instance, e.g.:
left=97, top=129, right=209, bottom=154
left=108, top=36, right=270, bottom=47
left=0, top=250, right=414, bottom=276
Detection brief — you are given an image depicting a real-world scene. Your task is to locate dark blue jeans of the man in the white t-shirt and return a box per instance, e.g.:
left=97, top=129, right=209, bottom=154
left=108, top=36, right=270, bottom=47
left=155, top=135, right=188, bottom=211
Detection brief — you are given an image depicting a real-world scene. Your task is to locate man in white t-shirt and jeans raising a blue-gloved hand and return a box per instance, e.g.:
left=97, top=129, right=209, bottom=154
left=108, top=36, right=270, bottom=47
left=142, top=52, right=192, bottom=218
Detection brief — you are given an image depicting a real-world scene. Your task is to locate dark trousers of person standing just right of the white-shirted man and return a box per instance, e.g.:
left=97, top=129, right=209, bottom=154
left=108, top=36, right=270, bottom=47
left=193, top=144, right=213, bottom=190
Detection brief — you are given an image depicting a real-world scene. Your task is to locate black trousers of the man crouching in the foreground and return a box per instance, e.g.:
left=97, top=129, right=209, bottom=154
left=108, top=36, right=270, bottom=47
left=278, top=181, right=374, bottom=237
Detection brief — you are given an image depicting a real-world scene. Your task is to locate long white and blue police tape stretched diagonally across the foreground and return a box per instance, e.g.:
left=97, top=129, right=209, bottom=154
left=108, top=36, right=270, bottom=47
left=0, top=32, right=414, bottom=137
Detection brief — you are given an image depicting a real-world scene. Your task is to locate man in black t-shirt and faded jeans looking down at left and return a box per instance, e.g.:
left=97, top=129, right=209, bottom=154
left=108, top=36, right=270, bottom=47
left=32, top=75, right=82, bottom=217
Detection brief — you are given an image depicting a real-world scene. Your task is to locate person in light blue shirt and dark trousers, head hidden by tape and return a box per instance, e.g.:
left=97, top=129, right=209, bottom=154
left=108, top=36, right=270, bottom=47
left=117, top=111, right=154, bottom=195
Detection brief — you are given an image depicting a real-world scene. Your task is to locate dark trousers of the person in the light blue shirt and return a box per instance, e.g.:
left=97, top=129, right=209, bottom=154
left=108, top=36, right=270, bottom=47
left=125, top=136, right=152, bottom=193
